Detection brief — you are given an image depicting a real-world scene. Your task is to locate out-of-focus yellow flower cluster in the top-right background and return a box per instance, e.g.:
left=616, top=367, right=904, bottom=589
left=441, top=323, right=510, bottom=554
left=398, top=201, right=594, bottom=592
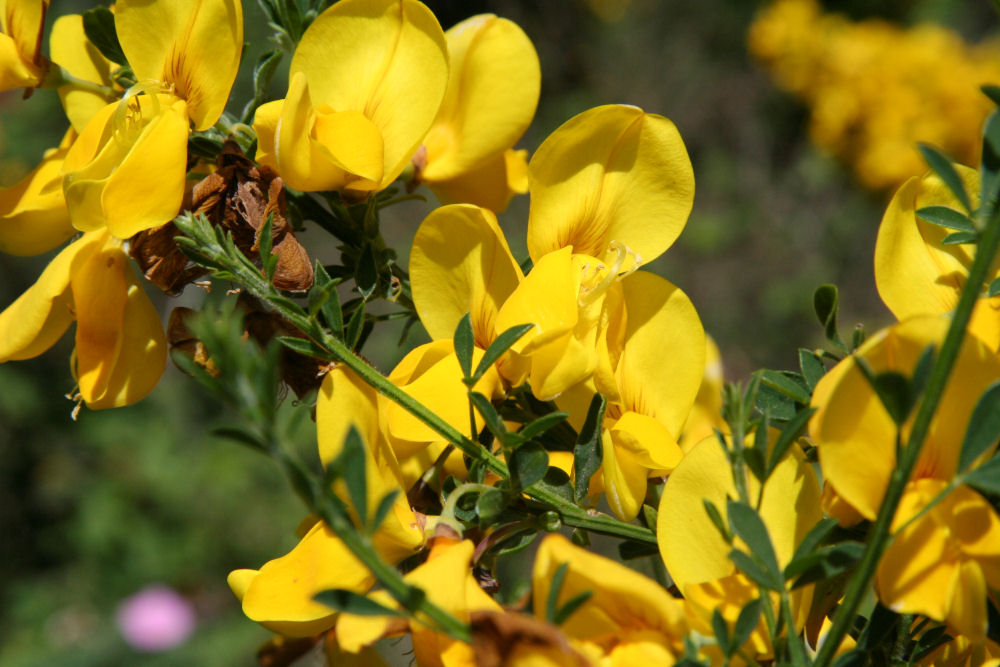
left=748, top=0, right=1000, bottom=189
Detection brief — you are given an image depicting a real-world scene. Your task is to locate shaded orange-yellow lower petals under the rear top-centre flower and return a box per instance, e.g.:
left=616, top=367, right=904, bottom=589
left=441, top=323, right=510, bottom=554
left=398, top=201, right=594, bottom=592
left=421, top=149, right=528, bottom=213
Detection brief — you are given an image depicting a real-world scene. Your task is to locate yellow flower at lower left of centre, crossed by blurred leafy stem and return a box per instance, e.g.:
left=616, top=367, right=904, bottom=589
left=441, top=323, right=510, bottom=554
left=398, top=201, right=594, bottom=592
left=229, top=367, right=423, bottom=637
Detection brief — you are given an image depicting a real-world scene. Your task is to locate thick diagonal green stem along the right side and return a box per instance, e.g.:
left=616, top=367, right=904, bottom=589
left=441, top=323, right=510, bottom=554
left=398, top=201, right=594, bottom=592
left=814, top=196, right=1000, bottom=667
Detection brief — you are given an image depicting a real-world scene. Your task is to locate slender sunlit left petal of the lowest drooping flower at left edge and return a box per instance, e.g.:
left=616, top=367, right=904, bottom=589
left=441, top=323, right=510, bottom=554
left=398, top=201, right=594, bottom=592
left=0, top=232, right=103, bottom=362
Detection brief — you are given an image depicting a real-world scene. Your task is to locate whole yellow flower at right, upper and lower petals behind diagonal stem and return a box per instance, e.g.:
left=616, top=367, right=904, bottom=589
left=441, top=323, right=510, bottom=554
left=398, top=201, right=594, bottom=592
left=809, top=316, right=1000, bottom=643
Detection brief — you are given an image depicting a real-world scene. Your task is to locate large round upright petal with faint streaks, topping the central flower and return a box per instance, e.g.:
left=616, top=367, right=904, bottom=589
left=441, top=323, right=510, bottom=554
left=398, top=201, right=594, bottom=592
left=528, top=105, right=694, bottom=264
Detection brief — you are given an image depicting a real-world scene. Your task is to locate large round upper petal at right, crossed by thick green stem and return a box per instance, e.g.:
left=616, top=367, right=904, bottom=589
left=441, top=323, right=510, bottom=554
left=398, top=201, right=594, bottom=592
left=809, top=316, right=1000, bottom=520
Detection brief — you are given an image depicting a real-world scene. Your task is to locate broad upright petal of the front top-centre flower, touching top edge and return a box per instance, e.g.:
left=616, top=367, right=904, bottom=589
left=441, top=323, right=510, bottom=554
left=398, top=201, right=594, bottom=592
left=289, top=0, right=448, bottom=190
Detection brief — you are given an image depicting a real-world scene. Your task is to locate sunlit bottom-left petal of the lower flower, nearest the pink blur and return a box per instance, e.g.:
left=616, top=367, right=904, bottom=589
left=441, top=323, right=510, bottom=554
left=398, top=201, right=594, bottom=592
left=237, top=522, right=375, bottom=637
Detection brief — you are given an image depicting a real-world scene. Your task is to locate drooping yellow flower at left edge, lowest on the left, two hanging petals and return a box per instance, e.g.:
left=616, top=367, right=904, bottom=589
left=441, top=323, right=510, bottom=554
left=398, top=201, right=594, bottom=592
left=0, top=231, right=166, bottom=410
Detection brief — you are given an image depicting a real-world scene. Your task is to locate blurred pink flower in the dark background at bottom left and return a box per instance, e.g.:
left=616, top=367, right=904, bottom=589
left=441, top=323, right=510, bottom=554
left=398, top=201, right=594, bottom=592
left=117, top=585, right=195, bottom=653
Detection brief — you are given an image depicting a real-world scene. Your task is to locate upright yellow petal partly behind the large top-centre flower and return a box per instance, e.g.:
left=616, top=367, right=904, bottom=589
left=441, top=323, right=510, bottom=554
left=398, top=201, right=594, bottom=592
left=421, top=14, right=541, bottom=183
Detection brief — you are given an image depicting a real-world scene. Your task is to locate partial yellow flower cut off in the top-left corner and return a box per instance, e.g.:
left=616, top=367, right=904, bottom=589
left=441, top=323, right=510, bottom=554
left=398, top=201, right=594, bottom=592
left=0, top=0, right=49, bottom=92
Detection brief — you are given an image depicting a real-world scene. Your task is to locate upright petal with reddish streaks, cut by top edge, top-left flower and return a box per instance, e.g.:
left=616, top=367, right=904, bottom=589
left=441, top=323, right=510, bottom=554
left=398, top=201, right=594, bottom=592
left=115, top=0, right=243, bottom=130
